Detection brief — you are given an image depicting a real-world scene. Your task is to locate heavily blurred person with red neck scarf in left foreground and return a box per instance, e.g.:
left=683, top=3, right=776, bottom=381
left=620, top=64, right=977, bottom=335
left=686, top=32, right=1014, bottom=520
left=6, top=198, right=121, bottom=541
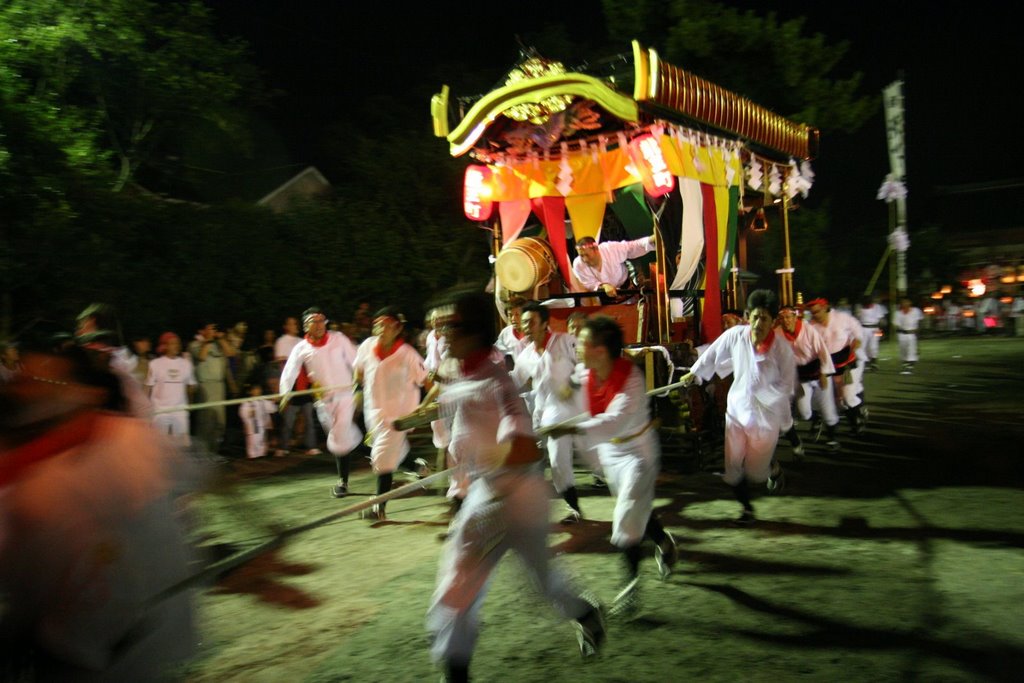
left=0, top=347, right=196, bottom=681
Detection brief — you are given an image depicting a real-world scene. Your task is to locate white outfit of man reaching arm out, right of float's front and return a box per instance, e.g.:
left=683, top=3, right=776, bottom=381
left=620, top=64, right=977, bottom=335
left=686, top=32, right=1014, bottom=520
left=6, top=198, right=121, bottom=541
left=690, top=325, right=797, bottom=485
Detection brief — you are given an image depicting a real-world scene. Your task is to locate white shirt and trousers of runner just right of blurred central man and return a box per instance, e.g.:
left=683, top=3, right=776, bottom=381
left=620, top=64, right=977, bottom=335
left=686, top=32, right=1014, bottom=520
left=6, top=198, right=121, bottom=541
left=577, top=366, right=660, bottom=548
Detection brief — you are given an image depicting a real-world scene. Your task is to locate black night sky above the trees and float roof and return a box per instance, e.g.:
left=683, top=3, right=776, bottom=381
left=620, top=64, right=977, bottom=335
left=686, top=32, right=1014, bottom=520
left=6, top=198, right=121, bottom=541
left=203, top=0, right=1024, bottom=231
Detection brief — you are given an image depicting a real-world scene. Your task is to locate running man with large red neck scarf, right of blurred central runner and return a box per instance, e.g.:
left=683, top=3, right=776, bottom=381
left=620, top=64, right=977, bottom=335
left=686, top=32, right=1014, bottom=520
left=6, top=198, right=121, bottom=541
left=551, top=315, right=679, bottom=617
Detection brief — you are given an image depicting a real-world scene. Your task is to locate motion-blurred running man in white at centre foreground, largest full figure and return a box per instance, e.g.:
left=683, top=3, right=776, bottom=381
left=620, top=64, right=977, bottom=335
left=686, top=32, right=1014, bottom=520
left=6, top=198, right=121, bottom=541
left=401, top=292, right=604, bottom=681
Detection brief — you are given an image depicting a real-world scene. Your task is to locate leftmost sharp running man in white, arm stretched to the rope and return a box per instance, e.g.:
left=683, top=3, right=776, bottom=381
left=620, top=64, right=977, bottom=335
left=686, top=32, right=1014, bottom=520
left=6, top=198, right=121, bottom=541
left=279, top=306, right=362, bottom=498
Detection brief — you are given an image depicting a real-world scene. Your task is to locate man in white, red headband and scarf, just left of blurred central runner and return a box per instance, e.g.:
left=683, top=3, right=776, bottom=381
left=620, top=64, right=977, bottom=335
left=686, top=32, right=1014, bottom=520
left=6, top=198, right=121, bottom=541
left=353, top=306, right=427, bottom=520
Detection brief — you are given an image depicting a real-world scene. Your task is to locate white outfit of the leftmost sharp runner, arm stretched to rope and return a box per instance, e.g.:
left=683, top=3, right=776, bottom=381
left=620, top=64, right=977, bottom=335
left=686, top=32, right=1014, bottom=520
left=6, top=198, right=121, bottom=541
left=281, top=330, right=362, bottom=455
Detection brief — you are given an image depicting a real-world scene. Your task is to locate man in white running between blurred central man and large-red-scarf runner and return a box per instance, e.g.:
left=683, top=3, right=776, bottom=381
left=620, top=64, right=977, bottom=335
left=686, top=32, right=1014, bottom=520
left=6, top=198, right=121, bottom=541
left=512, top=301, right=583, bottom=524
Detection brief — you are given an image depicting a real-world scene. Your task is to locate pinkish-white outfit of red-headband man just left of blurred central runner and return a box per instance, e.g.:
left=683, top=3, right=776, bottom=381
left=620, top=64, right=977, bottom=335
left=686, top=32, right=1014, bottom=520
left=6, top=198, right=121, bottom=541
left=353, top=337, right=427, bottom=474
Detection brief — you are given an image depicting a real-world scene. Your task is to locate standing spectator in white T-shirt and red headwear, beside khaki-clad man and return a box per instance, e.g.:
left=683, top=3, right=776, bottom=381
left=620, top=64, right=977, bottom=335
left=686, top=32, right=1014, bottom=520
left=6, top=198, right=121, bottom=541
left=145, top=332, right=196, bottom=446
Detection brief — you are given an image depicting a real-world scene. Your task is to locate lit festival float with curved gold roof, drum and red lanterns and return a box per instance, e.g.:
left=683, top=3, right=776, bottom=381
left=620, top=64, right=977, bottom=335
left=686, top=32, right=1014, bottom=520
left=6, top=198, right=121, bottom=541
left=431, top=41, right=819, bottom=462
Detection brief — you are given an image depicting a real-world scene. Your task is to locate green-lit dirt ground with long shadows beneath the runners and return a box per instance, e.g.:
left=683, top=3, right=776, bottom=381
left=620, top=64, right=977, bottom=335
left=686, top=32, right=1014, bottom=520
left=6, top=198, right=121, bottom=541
left=176, top=338, right=1024, bottom=683
